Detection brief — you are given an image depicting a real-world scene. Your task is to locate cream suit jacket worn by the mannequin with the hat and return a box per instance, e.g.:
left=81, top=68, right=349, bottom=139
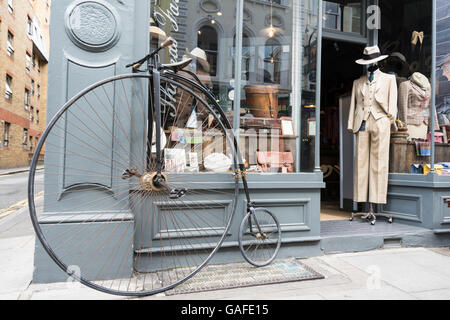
left=348, top=71, right=398, bottom=133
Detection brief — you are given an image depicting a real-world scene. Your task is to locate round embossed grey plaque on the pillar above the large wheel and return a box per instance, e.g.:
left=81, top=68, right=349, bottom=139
left=66, top=0, right=120, bottom=51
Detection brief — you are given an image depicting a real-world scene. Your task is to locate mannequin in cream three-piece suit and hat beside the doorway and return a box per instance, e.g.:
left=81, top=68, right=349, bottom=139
left=348, top=46, right=398, bottom=224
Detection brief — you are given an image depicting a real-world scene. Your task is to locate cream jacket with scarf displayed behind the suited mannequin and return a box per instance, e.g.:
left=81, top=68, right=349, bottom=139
left=398, top=81, right=439, bottom=130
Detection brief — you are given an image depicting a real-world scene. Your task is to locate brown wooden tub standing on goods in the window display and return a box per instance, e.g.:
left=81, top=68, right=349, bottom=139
left=244, top=85, right=279, bottom=118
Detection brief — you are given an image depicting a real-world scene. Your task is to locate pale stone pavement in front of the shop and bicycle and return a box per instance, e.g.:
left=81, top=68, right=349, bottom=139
left=0, top=166, right=450, bottom=300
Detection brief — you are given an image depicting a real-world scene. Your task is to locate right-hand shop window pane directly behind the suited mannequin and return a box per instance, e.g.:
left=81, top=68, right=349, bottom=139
left=379, top=0, right=447, bottom=174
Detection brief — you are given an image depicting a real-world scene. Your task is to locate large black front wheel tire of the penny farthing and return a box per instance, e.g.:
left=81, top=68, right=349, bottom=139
left=28, top=74, right=239, bottom=297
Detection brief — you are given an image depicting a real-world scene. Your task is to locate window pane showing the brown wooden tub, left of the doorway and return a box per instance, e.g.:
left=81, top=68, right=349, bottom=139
left=239, top=1, right=317, bottom=173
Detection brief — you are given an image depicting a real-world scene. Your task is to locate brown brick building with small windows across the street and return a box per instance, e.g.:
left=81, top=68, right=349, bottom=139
left=0, top=0, right=51, bottom=169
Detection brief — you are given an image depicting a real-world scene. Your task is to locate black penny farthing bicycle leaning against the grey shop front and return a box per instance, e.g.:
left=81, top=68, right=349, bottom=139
left=28, top=38, right=281, bottom=296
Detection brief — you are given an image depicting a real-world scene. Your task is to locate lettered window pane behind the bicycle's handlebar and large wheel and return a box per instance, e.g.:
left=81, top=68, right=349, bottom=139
left=150, top=0, right=236, bottom=176
